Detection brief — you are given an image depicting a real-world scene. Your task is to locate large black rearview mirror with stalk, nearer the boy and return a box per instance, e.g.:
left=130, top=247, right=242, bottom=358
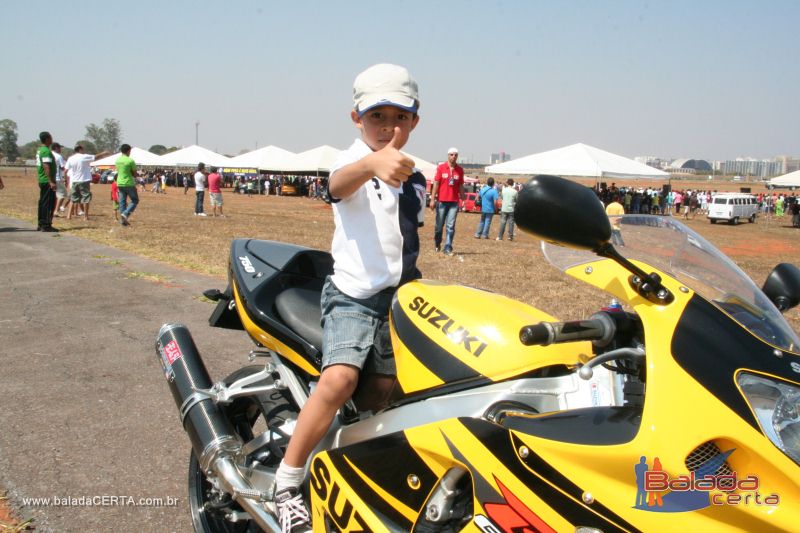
left=514, top=174, right=674, bottom=305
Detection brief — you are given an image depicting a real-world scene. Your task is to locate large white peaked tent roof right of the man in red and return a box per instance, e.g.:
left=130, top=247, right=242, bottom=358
left=485, top=143, right=669, bottom=179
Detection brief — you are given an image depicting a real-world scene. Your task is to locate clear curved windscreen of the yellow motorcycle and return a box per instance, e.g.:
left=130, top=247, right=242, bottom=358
left=542, top=215, right=800, bottom=351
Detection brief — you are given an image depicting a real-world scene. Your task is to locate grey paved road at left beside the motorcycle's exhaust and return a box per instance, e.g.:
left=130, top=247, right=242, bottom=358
left=0, top=216, right=252, bottom=532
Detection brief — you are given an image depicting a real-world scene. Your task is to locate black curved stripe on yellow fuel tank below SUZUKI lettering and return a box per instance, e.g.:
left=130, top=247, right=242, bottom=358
left=391, top=295, right=483, bottom=383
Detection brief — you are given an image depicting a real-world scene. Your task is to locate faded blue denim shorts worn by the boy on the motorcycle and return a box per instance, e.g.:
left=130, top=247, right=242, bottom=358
left=321, top=277, right=397, bottom=375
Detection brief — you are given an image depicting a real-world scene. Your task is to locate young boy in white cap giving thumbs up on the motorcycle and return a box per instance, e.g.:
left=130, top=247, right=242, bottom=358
left=275, top=64, right=425, bottom=532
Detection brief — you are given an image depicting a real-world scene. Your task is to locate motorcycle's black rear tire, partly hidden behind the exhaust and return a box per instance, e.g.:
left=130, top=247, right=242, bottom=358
left=189, top=366, right=298, bottom=533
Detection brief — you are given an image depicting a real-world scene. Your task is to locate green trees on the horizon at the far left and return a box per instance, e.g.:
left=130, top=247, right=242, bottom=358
left=0, top=118, right=178, bottom=163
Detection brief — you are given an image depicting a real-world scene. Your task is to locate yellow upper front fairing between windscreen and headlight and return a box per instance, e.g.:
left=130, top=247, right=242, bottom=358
left=552, top=260, right=800, bottom=531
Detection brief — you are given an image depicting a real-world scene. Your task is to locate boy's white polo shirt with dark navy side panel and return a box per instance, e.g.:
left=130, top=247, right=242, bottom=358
left=331, top=139, right=425, bottom=298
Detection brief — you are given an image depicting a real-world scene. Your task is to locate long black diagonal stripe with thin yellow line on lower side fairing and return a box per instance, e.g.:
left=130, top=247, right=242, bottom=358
left=459, top=418, right=639, bottom=533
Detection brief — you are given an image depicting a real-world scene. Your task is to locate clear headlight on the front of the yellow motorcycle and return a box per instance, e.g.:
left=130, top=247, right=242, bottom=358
left=736, top=372, right=800, bottom=464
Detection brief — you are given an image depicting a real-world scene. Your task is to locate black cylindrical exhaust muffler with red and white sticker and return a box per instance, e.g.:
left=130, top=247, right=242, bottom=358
left=156, top=324, right=241, bottom=472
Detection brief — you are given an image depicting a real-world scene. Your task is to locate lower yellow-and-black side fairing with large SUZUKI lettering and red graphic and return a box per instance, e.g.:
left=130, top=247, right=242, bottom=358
left=310, top=418, right=638, bottom=532
